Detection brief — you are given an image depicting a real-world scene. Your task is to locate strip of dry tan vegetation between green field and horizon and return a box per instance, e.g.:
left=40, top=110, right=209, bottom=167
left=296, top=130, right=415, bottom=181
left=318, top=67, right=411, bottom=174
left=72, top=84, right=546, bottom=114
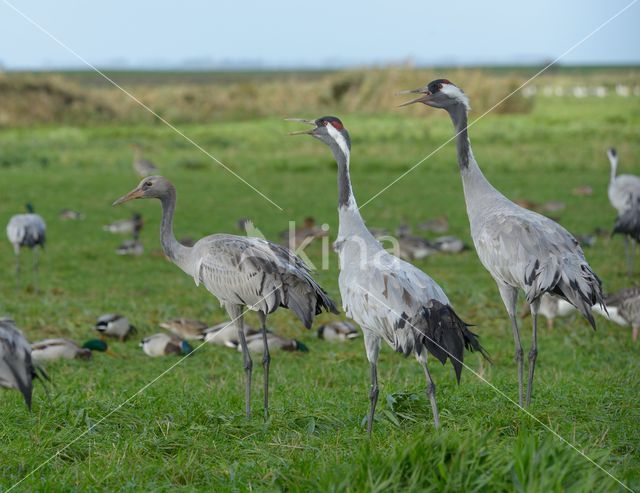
left=0, top=67, right=544, bottom=126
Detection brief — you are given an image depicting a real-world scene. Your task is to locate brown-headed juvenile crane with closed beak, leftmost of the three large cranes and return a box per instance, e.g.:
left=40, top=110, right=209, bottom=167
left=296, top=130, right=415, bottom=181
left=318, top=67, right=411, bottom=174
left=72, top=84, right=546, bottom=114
left=114, top=176, right=337, bottom=417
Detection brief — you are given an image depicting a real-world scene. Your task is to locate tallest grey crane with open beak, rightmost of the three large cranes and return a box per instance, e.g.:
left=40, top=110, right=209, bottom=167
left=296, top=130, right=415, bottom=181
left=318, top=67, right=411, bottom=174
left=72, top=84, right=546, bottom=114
left=403, top=79, right=604, bottom=406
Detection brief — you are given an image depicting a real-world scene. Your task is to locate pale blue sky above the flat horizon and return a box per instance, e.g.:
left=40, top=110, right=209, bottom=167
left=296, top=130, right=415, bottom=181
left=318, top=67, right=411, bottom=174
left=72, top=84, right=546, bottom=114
left=0, top=0, right=640, bottom=69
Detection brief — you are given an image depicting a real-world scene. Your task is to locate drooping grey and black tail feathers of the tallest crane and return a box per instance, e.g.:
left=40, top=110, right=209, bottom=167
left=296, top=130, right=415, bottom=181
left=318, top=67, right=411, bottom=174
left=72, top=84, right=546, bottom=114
left=525, top=257, right=606, bottom=330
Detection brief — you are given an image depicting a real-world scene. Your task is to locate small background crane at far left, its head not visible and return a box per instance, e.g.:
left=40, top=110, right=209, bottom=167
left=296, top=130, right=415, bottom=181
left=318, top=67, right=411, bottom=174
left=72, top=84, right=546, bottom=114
left=7, top=203, right=47, bottom=289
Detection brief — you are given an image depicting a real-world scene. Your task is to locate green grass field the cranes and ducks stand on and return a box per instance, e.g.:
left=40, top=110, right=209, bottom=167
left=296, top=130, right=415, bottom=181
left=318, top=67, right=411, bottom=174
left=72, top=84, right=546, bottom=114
left=0, top=81, right=640, bottom=492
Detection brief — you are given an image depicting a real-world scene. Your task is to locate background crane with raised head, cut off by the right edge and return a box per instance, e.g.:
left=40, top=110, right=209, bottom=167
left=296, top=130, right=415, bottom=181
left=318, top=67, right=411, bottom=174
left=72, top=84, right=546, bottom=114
left=607, top=147, right=640, bottom=276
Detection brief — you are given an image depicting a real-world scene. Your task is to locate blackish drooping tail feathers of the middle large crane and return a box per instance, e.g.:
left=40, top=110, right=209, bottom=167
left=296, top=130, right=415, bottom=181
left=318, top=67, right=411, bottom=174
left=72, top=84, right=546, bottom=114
left=414, top=300, right=491, bottom=383
